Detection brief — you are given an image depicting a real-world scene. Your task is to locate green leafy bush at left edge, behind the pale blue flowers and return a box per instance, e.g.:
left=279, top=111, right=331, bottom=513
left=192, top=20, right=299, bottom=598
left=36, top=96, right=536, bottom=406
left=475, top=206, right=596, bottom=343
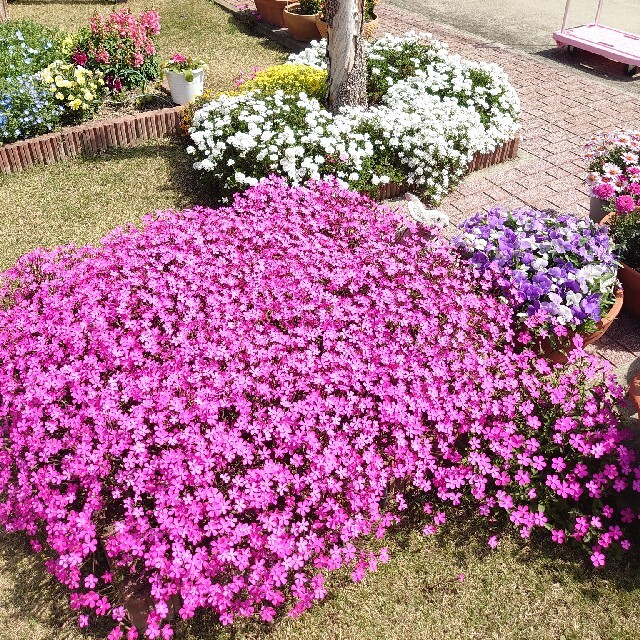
left=0, top=20, right=62, bottom=81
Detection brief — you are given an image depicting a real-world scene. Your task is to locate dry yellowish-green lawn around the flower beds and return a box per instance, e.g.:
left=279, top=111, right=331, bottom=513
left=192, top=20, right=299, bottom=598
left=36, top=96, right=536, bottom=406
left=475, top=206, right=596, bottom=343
left=0, top=0, right=640, bottom=640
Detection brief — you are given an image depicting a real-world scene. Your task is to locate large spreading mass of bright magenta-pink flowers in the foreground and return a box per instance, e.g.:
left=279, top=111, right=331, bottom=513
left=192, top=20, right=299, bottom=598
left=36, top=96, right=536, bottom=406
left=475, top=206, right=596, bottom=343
left=0, top=179, right=638, bottom=639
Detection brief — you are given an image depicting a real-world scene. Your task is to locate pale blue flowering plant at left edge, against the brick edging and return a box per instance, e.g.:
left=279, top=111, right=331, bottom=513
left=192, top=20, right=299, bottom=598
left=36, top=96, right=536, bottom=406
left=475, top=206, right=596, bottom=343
left=0, top=76, right=62, bottom=143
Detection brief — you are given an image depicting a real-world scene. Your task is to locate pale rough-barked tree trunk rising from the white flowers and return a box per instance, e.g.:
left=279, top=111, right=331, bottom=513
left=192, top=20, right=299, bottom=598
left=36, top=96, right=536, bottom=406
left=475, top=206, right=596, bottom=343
left=326, top=0, right=367, bottom=113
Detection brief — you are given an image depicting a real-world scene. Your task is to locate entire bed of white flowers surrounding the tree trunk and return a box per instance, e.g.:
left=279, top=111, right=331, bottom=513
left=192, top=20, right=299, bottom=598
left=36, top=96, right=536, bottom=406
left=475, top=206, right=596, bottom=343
left=187, top=33, right=520, bottom=203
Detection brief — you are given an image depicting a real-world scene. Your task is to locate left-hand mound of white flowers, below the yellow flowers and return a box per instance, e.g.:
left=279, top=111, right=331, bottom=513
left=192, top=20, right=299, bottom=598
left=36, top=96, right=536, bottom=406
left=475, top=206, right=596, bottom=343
left=187, top=91, right=389, bottom=191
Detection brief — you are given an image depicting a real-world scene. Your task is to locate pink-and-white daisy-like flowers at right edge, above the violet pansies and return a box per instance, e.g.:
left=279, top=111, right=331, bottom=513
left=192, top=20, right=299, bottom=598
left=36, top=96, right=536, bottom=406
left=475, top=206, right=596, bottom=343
left=583, top=129, right=640, bottom=222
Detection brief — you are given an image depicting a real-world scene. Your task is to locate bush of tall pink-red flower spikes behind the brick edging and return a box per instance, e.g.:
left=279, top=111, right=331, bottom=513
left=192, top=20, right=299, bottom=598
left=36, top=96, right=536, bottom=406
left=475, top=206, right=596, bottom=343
left=72, top=8, right=160, bottom=91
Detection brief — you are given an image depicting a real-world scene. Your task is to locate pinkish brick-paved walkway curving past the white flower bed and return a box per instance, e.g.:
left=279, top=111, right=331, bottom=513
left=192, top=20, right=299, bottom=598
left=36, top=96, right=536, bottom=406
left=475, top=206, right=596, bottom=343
left=378, top=5, right=640, bottom=382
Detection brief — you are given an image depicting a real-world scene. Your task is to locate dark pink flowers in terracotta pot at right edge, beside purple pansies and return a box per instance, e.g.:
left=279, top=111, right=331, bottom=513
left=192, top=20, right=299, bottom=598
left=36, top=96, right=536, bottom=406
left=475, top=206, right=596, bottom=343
left=602, top=206, right=640, bottom=320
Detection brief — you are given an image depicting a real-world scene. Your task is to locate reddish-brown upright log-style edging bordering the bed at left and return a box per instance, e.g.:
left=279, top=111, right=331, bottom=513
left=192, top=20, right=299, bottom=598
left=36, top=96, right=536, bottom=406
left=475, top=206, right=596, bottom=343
left=0, top=107, right=183, bottom=174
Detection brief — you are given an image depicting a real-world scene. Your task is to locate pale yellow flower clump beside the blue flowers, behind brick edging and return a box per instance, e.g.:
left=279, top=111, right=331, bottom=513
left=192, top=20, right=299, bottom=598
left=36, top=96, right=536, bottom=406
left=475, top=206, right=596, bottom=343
left=40, top=60, right=104, bottom=120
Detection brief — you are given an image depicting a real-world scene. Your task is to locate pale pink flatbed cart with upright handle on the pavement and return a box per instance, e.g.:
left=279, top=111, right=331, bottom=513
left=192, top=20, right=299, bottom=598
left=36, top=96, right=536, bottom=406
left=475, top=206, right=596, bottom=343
left=553, top=0, right=640, bottom=76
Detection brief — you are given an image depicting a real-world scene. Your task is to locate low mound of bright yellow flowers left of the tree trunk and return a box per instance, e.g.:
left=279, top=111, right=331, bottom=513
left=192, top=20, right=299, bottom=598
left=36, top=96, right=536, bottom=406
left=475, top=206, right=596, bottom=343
left=237, top=64, right=327, bottom=101
